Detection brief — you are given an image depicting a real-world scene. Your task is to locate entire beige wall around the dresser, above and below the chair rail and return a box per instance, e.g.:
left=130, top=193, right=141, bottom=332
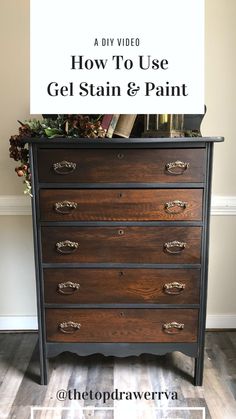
left=0, top=0, right=236, bottom=326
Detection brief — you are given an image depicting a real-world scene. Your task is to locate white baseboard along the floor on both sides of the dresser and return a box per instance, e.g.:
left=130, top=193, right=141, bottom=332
left=0, top=314, right=236, bottom=331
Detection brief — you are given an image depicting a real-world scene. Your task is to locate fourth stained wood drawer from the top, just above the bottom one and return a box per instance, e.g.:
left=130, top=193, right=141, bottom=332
left=44, top=269, right=200, bottom=304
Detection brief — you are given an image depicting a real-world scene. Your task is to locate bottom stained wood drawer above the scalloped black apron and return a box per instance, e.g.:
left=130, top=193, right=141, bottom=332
left=46, top=308, right=198, bottom=342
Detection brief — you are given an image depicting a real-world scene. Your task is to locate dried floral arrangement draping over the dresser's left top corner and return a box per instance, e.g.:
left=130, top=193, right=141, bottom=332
left=9, top=115, right=106, bottom=196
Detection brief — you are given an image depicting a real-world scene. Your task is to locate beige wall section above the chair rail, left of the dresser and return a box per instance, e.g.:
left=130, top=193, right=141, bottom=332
left=0, top=0, right=29, bottom=194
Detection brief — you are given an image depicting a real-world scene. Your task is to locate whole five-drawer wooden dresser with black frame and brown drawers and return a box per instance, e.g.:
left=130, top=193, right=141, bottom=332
left=29, top=138, right=222, bottom=385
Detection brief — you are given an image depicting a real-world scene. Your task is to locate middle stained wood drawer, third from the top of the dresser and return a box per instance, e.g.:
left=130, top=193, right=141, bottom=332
left=42, top=226, right=201, bottom=264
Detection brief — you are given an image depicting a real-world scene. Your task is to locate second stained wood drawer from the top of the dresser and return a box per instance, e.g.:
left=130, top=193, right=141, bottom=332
left=40, top=189, right=202, bottom=221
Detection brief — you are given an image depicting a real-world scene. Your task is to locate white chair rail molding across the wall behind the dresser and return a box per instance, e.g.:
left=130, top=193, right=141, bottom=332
left=0, top=195, right=236, bottom=215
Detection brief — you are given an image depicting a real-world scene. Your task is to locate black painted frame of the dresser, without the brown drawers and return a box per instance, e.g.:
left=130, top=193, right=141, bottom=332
left=27, top=137, right=223, bottom=386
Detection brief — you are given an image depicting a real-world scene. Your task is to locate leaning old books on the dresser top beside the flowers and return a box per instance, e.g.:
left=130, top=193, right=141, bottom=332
left=102, top=114, right=137, bottom=138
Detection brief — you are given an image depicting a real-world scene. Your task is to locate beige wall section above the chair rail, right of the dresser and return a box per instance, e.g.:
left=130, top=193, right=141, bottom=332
left=202, top=0, right=236, bottom=196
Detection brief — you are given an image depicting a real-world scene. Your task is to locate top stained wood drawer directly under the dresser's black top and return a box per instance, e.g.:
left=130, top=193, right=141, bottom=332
left=38, top=148, right=205, bottom=183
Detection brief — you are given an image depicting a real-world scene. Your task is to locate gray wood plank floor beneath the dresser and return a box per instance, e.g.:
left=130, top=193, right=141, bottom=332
left=0, top=332, right=236, bottom=419
